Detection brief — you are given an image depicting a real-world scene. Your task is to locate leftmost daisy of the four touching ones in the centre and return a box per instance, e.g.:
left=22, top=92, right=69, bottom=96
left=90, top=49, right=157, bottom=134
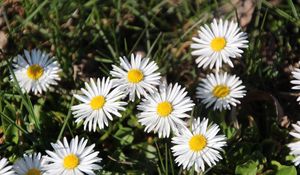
left=71, top=78, right=127, bottom=131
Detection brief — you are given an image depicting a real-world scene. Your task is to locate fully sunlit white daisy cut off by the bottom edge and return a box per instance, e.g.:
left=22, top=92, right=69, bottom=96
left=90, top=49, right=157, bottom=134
left=43, top=136, right=101, bottom=175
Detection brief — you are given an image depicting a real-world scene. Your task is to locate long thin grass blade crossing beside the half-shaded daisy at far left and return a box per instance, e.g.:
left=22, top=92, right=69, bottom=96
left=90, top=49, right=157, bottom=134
left=6, top=60, right=41, bottom=132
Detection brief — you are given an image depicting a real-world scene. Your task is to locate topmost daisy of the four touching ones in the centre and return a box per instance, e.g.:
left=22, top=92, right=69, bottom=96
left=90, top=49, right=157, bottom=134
left=110, top=54, right=161, bottom=101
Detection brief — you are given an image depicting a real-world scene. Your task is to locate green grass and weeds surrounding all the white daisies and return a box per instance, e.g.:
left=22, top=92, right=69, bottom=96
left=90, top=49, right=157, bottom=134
left=0, top=0, right=300, bottom=175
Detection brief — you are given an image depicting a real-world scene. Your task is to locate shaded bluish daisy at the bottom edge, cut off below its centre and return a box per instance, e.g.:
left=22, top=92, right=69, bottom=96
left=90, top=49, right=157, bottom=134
left=13, top=153, right=43, bottom=175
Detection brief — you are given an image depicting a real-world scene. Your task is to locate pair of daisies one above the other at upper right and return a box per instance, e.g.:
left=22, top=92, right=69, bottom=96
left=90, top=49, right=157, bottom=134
left=191, top=19, right=248, bottom=111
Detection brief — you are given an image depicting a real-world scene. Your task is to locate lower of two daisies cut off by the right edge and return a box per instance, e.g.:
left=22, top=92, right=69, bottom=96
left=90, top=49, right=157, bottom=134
left=288, top=121, right=300, bottom=166
